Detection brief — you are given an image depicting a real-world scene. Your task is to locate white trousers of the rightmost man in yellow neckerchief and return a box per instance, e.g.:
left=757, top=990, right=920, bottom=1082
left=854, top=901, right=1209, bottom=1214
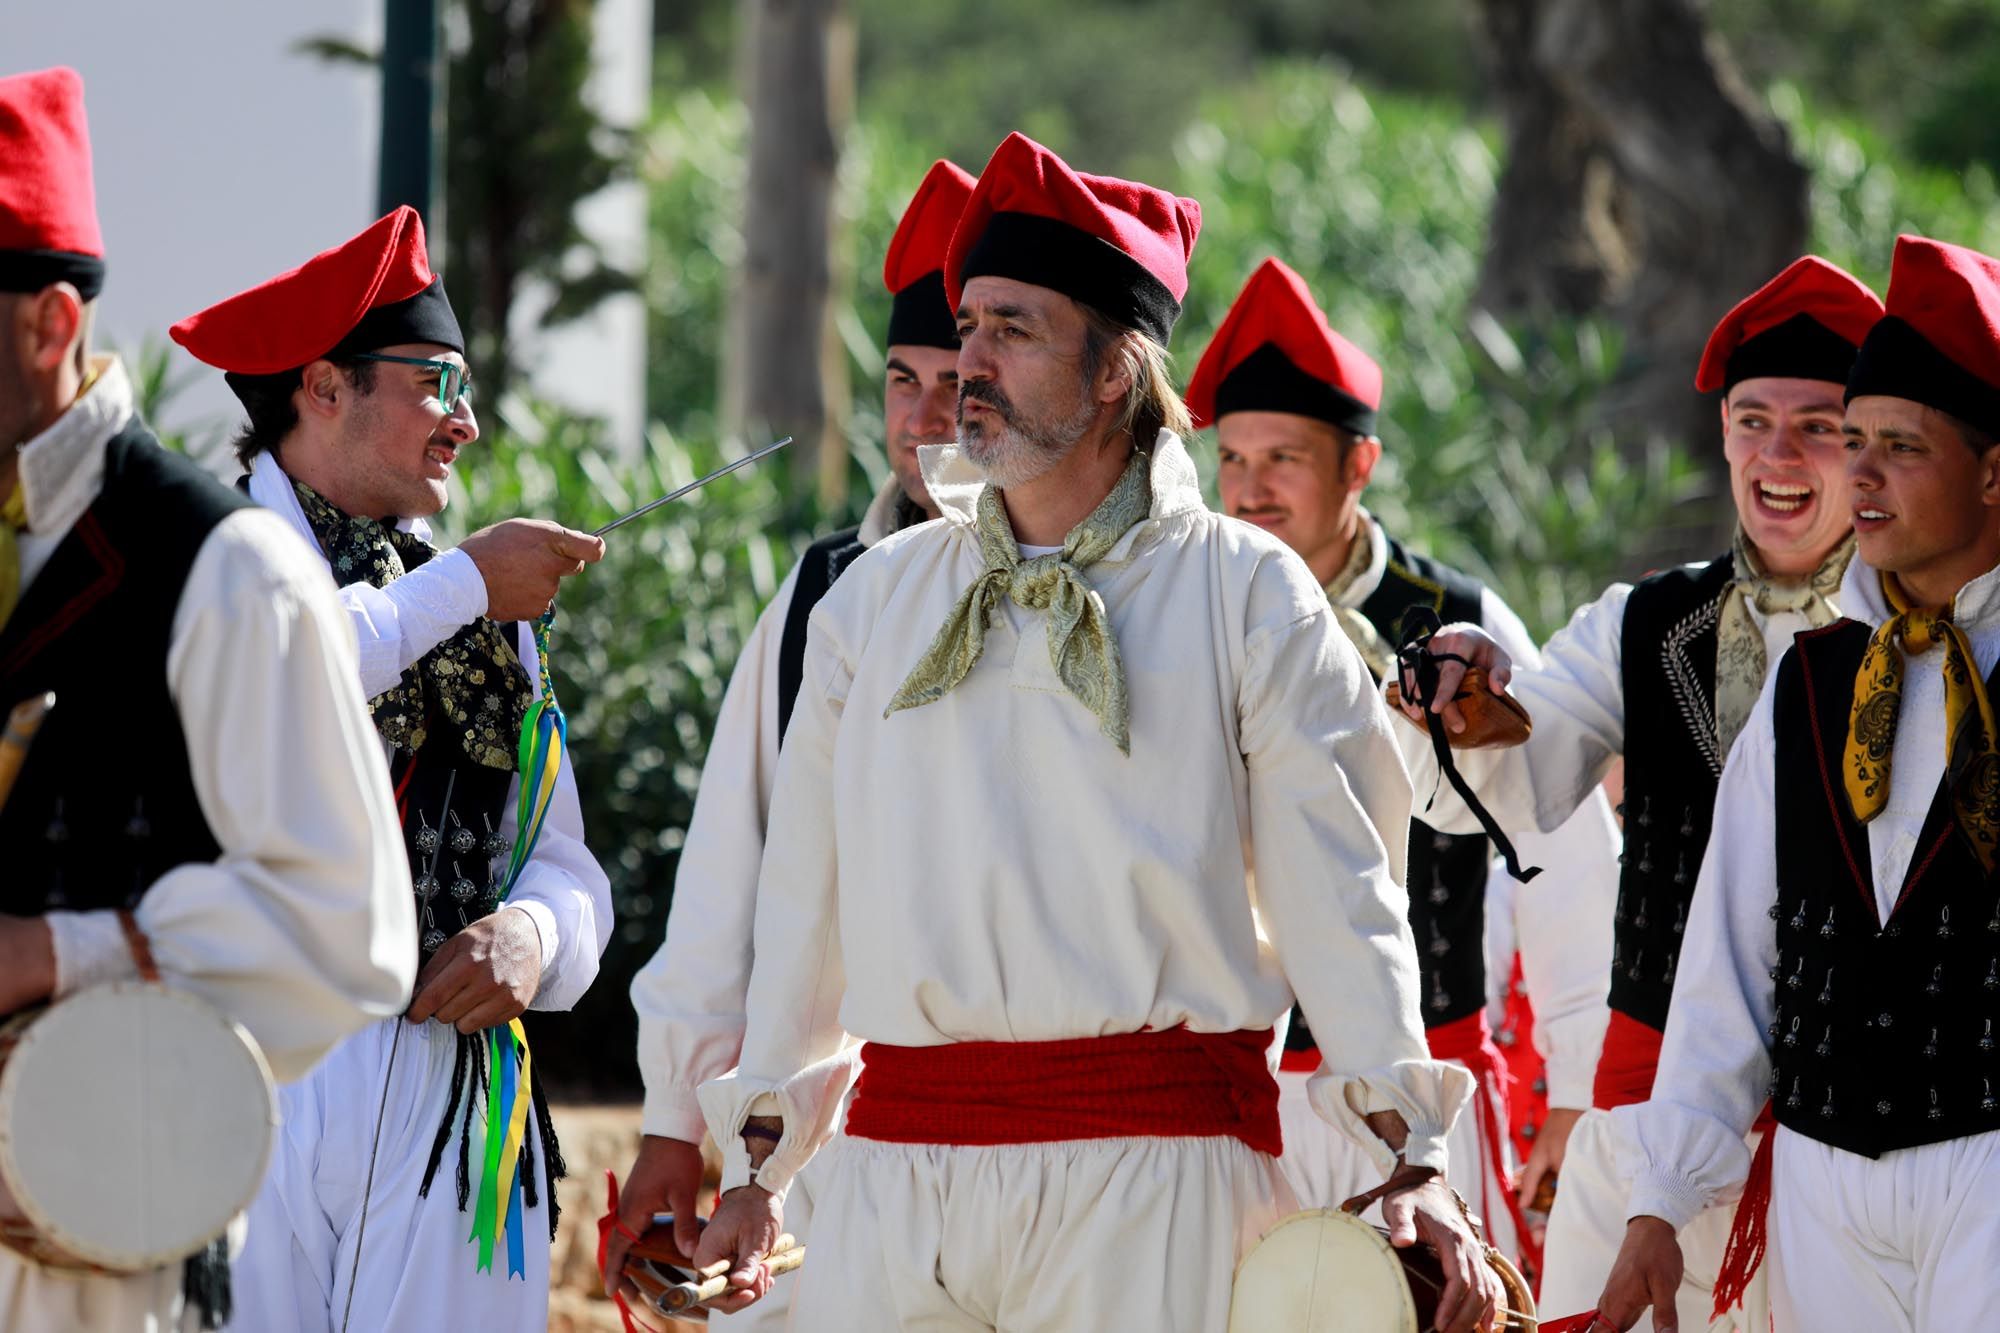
left=1770, top=1127, right=2000, bottom=1333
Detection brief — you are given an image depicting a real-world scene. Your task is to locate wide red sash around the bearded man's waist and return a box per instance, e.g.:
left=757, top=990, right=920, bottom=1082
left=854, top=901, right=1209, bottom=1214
left=846, top=1027, right=1284, bottom=1157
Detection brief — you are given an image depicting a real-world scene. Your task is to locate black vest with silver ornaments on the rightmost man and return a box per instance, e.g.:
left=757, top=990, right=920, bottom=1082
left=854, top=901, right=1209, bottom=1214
left=1768, top=620, right=2000, bottom=1157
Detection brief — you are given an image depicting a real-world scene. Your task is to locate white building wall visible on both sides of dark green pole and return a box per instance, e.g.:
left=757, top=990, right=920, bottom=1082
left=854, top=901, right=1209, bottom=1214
left=17, top=0, right=652, bottom=462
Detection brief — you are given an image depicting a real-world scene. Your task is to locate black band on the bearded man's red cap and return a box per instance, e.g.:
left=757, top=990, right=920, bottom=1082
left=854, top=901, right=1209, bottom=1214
left=958, top=212, right=1180, bottom=346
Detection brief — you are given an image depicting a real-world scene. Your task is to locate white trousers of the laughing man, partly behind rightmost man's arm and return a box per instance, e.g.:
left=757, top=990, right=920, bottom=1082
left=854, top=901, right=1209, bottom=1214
left=1538, top=1109, right=1768, bottom=1333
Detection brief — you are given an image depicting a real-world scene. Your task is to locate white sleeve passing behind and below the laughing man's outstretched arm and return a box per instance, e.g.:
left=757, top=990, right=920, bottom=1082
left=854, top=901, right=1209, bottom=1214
left=1480, top=590, right=1624, bottom=1111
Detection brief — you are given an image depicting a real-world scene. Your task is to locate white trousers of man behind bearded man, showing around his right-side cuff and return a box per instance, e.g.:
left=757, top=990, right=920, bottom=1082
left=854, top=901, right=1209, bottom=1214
left=1278, top=1061, right=1520, bottom=1261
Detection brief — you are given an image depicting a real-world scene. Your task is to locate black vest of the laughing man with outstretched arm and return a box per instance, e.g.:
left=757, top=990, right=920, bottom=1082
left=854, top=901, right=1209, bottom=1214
left=1610, top=556, right=1732, bottom=1031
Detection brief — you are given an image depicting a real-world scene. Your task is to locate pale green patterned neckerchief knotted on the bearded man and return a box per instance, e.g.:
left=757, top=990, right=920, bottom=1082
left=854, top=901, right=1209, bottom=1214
left=882, top=450, right=1152, bottom=755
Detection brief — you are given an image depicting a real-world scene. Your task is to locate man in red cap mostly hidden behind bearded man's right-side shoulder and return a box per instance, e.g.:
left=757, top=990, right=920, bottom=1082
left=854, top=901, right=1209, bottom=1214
left=1188, top=258, right=1618, bottom=1257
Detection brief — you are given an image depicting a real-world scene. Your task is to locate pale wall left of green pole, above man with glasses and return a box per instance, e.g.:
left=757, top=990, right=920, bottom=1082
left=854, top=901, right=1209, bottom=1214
left=12, top=0, right=382, bottom=452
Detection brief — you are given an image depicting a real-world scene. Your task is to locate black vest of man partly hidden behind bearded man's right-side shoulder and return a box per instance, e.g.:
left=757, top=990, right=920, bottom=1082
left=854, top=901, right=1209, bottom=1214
left=1284, top=540, right=1492, bottom=1051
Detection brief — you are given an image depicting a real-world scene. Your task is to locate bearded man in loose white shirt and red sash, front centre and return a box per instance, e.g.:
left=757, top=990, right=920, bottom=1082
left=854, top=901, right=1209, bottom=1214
left=680, top=134, right=1498, bottom=1333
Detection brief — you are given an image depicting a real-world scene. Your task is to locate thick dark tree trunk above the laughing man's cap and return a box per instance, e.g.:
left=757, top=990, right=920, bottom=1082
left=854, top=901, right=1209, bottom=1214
left=1478, top=0, right=1810, bottom=532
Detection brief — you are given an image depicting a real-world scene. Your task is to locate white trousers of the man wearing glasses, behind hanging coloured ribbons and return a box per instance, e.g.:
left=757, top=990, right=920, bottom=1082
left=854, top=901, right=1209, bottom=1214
left=230, top=1019, right=548, bottom=1333
